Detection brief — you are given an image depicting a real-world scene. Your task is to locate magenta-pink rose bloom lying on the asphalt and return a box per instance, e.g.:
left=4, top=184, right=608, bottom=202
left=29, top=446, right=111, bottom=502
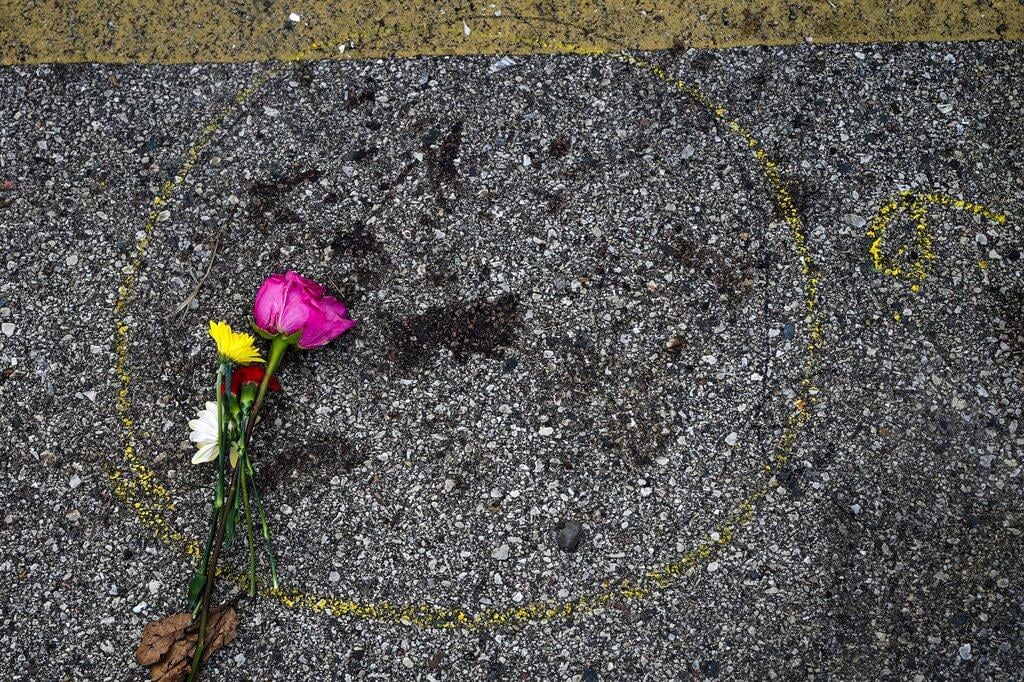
left=253, top=271, right=355, bottom=348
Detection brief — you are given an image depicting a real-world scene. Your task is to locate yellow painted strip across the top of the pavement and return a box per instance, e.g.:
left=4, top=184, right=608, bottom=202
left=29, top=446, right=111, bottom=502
left=0, top=0, right=1024, bottom=65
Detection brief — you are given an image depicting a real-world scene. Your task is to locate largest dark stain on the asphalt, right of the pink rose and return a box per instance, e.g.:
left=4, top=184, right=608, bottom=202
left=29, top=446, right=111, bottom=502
left=390, top=294, right=519, bottom=369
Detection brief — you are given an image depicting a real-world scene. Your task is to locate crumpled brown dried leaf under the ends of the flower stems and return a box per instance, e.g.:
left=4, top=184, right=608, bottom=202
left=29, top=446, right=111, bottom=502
left=135, top=606, right=239, bottom=682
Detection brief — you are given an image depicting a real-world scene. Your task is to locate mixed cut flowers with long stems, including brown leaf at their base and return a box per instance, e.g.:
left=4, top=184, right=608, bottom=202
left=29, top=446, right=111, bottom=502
left=137, top=271, right=355, bottom=680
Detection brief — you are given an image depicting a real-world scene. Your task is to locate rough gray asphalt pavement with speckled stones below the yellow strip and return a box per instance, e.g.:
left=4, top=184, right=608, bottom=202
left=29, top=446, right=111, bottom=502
left=0, top=43, right=1024, bottom=680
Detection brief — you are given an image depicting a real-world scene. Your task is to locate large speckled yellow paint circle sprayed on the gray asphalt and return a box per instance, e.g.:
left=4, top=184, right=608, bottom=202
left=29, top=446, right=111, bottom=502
left=109, top=37, right=821, bottom=629
